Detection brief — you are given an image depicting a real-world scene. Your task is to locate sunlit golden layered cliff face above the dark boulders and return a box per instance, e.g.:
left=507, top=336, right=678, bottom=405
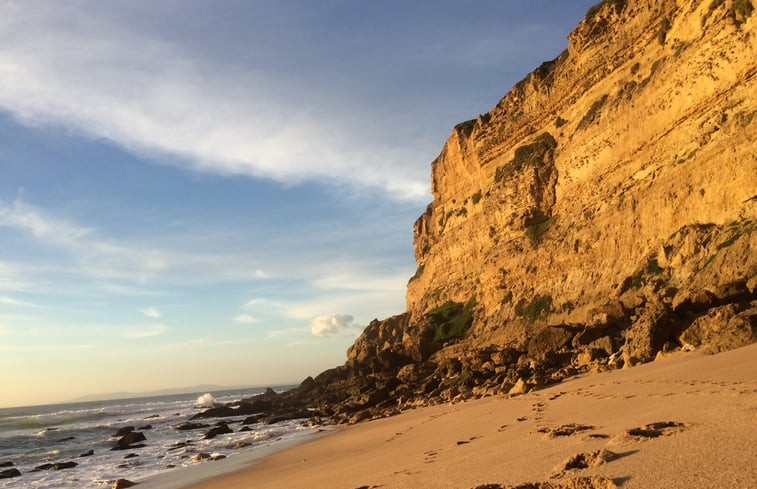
left=407, top=0, right=757, bottom=344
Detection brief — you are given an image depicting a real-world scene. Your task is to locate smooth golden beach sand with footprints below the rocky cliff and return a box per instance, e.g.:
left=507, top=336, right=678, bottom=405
left=151, top=345, right=757, bottom=489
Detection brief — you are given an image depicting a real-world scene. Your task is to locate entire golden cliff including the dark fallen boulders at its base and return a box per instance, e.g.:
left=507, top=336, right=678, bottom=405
left=216, top=0, right=757, bottom=421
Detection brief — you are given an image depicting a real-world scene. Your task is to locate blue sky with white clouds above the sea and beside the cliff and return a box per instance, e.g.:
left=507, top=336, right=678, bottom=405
left=0, top=0, right=594, bottom=407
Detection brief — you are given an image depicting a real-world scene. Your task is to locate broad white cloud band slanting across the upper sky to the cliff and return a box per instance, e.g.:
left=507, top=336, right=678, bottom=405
left=0, top=2, right=428, bottom=201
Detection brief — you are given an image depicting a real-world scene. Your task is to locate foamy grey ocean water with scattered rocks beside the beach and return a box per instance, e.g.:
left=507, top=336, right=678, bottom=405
left=0, top=389, right=316, bottom=489
